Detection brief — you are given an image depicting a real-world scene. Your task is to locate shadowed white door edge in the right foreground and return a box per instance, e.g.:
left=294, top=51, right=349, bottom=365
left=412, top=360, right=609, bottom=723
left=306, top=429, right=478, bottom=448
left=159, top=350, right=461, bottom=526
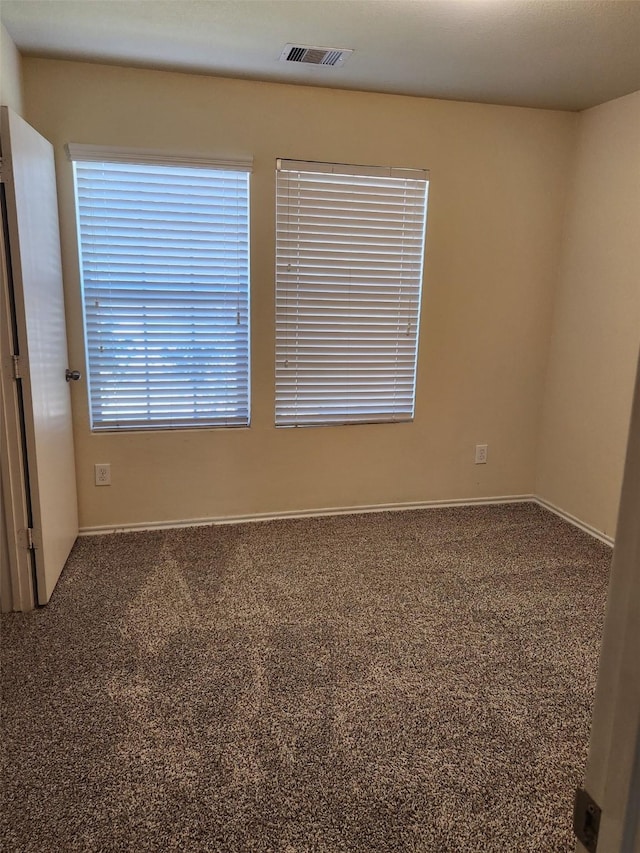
left=576, top=350, right=640, bottom=853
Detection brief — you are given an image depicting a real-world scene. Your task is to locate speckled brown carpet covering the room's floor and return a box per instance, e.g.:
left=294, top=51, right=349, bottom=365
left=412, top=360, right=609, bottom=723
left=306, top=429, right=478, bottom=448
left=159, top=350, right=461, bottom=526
left=0, top=504, right=611, bottom=853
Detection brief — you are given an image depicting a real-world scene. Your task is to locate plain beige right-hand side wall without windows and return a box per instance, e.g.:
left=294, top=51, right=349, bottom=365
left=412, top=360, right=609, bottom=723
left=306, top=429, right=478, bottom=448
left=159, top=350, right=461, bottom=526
left=537, top=92, right=640, bottom=535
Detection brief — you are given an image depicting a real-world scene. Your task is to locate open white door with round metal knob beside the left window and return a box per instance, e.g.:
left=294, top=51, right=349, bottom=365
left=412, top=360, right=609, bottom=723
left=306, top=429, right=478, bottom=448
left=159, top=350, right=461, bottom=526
left=0, top=107, right=78, bottom=604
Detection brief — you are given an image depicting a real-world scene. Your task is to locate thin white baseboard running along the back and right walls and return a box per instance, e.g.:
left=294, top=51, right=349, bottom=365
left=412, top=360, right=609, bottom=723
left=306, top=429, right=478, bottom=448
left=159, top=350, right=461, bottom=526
left=79, top=495, right=613, bottom=546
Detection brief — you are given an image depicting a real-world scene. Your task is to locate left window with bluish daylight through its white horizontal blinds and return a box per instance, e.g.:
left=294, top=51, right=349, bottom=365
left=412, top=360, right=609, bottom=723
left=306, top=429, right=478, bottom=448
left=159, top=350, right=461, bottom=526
left=68, top=145, right=250, bottom=430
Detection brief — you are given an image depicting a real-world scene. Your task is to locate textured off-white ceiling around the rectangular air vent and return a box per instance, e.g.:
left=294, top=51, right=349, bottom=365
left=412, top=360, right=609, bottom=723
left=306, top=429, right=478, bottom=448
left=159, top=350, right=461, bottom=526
left=0, top=0, right=640, bottom=110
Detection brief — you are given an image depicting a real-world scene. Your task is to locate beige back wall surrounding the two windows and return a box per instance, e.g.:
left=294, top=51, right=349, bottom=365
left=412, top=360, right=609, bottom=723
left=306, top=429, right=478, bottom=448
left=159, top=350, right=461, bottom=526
left=23, top=59, right=577, bottom=527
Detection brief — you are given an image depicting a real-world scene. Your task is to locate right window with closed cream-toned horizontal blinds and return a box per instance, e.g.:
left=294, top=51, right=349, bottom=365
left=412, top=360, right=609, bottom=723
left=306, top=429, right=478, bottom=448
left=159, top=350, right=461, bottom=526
left=276, top=160, right=427, bottom=426
